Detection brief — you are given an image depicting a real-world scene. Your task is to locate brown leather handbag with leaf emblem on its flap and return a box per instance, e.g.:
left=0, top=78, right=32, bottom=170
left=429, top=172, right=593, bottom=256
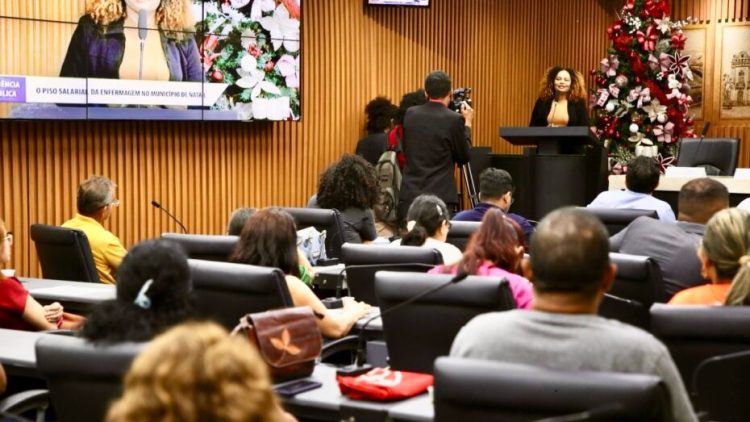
left=232, top=306, right=322, bottom=383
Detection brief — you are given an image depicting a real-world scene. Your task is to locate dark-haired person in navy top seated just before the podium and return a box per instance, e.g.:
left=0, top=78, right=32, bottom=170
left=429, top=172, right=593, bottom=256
left=453, top=167, right=534, bottom=242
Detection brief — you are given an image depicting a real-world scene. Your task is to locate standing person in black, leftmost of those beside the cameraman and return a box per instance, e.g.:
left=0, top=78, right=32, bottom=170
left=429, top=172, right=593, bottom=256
left=356, top=97, right=398, bottom=166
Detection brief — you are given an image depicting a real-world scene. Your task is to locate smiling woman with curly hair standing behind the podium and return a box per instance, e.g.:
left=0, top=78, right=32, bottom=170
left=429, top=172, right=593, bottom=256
left=529, top=66, right=589, bottom=127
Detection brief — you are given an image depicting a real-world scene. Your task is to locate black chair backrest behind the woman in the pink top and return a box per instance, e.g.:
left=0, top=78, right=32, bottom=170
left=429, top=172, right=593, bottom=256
left=375, top=271, right=516, bottom=373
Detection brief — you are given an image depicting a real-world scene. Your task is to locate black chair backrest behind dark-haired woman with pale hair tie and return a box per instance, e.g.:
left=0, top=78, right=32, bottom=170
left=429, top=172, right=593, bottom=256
left=36, top=334, right=146, bottom=422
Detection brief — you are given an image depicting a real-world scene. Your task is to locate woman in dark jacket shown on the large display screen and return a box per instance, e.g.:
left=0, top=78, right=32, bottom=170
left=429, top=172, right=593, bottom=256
left=60, top=0, right=203, bottom=81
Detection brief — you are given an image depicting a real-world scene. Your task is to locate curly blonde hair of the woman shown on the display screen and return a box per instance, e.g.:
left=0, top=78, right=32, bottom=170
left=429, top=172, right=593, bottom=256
left=86, top=0, right=195, bottom=40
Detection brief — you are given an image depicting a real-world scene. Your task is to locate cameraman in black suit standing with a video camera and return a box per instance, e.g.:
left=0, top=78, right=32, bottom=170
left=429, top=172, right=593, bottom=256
left=398, top=70, right=474, bottom=223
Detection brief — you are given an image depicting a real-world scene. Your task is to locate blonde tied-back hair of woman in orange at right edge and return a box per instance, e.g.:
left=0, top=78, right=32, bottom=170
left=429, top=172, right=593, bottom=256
left=701, top=208, right=750, bottom=306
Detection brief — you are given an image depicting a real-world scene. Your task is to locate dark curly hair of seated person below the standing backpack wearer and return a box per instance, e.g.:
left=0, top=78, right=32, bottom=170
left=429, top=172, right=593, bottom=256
left=318, top=154, right=380, bottom=211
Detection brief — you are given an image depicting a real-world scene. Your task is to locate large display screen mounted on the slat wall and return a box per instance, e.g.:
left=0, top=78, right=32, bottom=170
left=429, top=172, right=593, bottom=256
left=0, top=0, right=301, bottom=121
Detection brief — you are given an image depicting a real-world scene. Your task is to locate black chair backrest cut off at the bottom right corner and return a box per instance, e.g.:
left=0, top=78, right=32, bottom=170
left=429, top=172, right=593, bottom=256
left=693, top=350, right=750, bottom=422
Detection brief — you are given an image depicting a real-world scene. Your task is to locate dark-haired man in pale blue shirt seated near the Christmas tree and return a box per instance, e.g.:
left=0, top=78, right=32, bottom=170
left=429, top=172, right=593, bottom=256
left=588, top=156, right=677, bottom=223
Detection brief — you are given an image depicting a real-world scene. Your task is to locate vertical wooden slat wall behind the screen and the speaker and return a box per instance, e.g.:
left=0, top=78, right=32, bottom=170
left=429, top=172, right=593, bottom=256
left=0, top=0, right=750, bottom=276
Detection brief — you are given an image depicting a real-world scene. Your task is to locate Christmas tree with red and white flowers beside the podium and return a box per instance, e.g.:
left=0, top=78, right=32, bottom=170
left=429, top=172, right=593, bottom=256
left=590, top=0, right=695, bottom=173
